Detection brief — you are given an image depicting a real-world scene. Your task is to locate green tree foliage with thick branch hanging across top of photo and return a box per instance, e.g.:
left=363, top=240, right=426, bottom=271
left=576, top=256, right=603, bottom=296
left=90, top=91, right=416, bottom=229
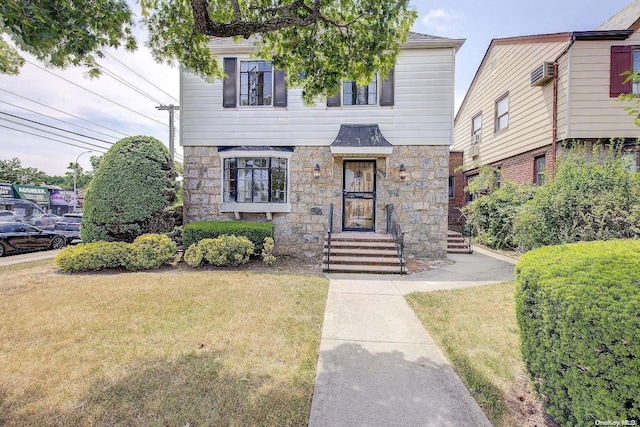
left=0, top=0, right=417, bottom=101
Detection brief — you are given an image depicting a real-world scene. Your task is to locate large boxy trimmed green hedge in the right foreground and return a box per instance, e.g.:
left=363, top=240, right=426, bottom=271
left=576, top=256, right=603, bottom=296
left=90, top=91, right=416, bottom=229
left=516, top=240, right=640, bottom=425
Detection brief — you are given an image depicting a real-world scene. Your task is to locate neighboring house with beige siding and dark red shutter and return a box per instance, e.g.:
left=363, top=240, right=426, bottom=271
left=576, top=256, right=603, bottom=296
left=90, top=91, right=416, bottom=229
left=450, top=0, right=640, bottom=205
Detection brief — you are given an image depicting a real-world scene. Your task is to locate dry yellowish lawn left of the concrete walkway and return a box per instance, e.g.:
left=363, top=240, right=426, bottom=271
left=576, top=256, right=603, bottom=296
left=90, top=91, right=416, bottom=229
left=0, top=260, right=328, bottom=426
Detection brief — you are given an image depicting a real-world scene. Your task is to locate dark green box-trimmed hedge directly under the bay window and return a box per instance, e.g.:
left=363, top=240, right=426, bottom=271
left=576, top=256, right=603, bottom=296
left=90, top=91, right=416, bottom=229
left=182, top=221, right=273, bottom=252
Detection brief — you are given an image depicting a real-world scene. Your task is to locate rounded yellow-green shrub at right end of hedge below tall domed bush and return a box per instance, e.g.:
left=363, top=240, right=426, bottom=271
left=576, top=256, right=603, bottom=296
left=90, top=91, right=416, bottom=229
left=124, top=234, right=176, bottom=271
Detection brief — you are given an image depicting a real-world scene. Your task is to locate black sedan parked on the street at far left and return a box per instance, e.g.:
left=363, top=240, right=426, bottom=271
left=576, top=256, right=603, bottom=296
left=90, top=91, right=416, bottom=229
left=0, top=222, right=67, bottom=257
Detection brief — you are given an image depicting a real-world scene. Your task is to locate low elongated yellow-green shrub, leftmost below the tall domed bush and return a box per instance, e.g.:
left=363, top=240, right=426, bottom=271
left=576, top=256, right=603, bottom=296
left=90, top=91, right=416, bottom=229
left=55, top=242, right=130, bottom=273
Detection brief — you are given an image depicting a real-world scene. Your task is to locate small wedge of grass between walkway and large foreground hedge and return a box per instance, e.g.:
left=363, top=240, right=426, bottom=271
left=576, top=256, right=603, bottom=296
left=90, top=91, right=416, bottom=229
left=406, top=282, right=545, bottom=426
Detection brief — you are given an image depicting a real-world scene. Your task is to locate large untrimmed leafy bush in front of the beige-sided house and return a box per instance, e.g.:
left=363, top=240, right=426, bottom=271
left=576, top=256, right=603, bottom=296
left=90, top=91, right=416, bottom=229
left=515, top=143, right=640, bottom=250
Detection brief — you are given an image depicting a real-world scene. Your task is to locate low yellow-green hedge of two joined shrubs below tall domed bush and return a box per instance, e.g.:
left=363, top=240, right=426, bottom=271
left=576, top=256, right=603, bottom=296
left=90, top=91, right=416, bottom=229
left=56, top=234, right=176, bottom=273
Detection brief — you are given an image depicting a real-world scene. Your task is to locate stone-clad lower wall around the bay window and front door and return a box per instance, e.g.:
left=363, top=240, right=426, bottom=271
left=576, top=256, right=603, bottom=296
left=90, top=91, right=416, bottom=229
left=184, top=146, right=449, bottom=258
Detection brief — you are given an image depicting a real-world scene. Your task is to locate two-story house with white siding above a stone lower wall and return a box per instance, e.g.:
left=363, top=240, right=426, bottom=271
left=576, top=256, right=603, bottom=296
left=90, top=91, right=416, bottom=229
left=180, top=33, right=463, bottom=257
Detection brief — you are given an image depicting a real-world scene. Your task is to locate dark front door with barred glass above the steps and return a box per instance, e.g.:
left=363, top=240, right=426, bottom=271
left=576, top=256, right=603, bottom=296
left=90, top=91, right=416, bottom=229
left=342, top=160, right=376, bottom=231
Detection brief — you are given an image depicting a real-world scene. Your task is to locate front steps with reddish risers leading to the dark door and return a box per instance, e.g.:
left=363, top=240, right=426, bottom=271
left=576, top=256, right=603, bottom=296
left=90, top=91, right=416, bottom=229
left=322, top=232, right=402, bottom=274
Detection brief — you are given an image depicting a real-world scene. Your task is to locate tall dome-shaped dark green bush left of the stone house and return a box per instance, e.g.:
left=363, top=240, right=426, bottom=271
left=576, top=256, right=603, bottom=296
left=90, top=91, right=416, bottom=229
left=81, top=136, right=178, bottom=242
